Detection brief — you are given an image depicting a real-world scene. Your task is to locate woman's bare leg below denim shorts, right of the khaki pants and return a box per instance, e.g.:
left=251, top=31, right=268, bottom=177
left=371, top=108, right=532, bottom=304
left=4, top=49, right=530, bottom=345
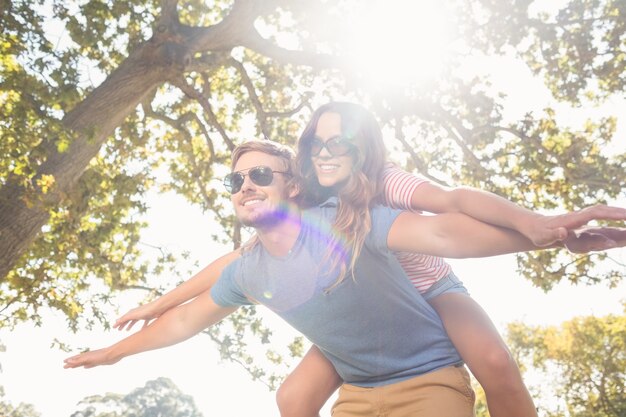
left=428, top=293, right=537, bottom=417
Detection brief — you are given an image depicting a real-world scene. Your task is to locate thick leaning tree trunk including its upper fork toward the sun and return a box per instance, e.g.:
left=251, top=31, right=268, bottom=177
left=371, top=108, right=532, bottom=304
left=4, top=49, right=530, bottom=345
left=0, top=0, right=292, bottom=280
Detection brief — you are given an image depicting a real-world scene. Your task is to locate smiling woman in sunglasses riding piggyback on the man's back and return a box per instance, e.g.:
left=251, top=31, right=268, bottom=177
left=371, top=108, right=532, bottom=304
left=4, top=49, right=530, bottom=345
left=114, top=103, right=616, bottom=417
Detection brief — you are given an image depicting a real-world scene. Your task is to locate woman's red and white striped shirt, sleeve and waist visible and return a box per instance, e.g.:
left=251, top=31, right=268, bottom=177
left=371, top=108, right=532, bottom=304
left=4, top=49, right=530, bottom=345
left=383, top=164, right=452, bottom=294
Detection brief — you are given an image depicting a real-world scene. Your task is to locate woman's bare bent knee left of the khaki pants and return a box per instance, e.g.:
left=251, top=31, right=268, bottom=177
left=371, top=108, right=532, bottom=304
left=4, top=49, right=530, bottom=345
left=276, top=346, right=342, bottom=417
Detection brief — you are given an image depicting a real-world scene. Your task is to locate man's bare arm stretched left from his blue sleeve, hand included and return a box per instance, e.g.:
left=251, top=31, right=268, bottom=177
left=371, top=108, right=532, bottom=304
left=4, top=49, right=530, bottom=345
left=64, top=291, right=237, bottom=368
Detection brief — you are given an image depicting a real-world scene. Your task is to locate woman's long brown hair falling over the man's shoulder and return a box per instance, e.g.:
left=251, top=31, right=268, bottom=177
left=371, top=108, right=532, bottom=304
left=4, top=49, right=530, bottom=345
left=296, top=102, right=386, bottom=290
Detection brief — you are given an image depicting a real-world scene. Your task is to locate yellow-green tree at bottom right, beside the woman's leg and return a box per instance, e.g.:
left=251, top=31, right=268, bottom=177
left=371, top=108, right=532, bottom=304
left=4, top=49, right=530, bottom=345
left=508, top=304, right=626, bottom=417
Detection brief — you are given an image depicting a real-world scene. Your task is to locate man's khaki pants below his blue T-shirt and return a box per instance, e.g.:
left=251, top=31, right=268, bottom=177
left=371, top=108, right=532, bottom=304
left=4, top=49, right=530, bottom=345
left=331, top=366, right=475, bottom=417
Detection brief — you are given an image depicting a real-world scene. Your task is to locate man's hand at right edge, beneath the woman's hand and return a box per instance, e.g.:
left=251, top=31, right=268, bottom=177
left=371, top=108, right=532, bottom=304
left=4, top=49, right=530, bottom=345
left=563, top=227, right=626, bottom=253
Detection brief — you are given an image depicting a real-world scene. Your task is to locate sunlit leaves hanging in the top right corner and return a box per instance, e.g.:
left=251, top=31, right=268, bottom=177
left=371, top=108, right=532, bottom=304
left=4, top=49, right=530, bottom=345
left=454, top=0, right=626, bottom=103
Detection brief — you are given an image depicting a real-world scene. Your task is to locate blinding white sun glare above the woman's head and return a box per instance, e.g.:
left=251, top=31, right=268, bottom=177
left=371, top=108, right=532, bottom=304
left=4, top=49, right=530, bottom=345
left=346, top=0, right=452, bottom=87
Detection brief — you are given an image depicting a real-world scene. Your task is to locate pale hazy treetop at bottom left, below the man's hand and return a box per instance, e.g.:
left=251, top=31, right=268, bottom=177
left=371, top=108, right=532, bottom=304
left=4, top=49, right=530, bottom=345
left=71, top=378, right=202, bottom=417
